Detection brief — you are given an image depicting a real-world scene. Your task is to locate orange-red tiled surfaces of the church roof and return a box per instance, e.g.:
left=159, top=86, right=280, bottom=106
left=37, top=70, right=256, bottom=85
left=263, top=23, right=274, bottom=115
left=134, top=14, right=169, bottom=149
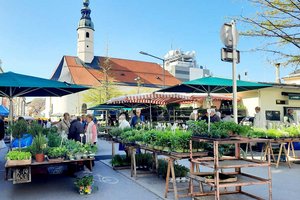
left=60, top=56, right=180, bottom=86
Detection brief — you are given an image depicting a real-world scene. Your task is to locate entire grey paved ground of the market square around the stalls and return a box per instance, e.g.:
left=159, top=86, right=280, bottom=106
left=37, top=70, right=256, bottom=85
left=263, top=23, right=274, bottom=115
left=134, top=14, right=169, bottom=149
left=0, top=141, right=300, bottom=200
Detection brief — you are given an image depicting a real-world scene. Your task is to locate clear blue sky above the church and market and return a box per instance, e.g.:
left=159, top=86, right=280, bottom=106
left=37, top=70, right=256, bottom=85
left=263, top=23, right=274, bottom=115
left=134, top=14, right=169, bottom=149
left=0, top=0, right=293, bottom=81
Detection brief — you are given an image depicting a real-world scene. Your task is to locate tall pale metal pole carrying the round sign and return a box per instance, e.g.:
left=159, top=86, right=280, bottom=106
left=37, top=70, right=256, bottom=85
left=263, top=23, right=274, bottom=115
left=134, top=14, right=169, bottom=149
left=231, top=20, right=238, bottom=123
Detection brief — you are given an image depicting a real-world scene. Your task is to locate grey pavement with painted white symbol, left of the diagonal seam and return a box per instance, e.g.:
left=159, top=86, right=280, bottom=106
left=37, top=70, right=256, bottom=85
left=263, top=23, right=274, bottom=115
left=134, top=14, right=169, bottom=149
left=0, top=141, right=161, bottom=200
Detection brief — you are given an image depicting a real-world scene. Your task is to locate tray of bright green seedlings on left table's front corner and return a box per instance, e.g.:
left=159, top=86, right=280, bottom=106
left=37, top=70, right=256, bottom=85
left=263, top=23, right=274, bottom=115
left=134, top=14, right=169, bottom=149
left=5, top=151, right=31, bottom=166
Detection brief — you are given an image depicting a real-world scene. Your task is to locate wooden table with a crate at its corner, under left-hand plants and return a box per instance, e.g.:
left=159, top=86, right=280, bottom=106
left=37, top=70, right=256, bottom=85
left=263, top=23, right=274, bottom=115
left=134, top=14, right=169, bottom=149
left=4, top=158, right=95, bottom=183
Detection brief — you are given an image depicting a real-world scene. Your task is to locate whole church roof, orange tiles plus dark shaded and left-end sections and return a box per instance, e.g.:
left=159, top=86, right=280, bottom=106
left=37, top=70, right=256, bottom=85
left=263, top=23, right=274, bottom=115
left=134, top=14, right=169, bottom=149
left=51, top=56, right=180, bottom=87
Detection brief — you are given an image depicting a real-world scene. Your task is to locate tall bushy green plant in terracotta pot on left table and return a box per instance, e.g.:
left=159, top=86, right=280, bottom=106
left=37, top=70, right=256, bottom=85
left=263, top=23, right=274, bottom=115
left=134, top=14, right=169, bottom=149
left=31, top=133, right=47, bottom=162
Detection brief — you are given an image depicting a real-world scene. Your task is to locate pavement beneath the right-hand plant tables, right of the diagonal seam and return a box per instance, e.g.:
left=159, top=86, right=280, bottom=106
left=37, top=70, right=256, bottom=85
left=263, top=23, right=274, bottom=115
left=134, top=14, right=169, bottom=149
left=100, top=141, right=300, bottom=200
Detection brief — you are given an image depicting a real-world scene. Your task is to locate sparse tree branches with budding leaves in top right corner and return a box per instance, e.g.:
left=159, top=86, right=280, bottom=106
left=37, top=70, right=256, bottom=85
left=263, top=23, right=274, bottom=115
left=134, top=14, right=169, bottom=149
left=237, top=0, right=300, bottom=65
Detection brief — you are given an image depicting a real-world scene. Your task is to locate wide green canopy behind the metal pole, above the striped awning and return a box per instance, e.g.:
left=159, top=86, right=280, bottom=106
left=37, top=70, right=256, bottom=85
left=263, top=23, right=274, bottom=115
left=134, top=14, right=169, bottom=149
left=159, top=77, right=272, bottom=93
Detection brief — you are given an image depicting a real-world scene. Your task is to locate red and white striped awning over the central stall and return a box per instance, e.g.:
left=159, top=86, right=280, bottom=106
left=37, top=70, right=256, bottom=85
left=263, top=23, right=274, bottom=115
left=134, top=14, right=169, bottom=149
left=107, top=92, right=238, bottom=105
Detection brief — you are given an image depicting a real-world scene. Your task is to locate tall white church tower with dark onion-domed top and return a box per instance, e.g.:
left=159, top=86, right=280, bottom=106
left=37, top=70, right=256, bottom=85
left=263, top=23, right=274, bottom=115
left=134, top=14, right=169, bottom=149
left=77, top=0, right=95, bottom=63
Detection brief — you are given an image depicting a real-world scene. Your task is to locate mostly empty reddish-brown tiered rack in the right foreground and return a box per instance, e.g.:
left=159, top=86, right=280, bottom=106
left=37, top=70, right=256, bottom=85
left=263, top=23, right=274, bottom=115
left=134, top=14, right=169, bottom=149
left=190, top=137, right=272, bottom=200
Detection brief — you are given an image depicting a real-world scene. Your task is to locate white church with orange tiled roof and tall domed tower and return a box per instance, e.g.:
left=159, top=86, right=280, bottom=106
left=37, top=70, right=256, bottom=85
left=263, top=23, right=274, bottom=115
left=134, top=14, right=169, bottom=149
left=45, top=0, right=180, bottom=117
